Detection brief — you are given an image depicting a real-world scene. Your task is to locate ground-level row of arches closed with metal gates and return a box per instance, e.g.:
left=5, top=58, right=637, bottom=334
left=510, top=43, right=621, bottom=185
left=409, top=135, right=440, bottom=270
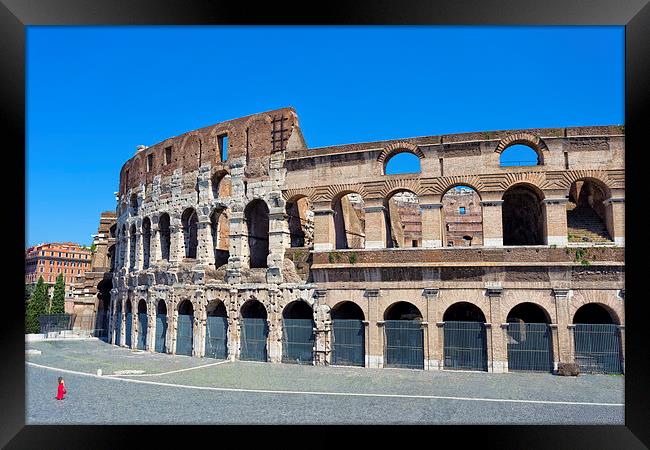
left=115, top=299, right=622, bottom=373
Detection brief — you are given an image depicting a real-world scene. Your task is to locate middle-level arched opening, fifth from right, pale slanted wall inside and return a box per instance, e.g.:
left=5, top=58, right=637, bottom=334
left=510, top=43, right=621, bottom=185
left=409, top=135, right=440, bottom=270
left=332, top=193, right=366, bottom=249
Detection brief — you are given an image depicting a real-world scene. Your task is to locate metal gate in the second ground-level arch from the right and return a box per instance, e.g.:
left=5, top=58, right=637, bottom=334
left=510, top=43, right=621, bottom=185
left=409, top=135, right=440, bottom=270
left=508, top=323, right=553, bottom=372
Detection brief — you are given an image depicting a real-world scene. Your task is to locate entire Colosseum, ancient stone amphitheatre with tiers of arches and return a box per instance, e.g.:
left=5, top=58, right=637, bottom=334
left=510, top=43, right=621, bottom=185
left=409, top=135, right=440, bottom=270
left=86, top=108, right=625, bottom=373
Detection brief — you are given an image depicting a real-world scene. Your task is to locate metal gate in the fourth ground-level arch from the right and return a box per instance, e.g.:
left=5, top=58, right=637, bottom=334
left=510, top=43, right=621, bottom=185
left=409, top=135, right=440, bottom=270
left=384, top=320, right=424, bottom=369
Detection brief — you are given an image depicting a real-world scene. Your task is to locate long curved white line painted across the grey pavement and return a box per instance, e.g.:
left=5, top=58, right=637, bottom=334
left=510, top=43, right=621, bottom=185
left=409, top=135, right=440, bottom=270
left=26, top=362, right=625, bottom=406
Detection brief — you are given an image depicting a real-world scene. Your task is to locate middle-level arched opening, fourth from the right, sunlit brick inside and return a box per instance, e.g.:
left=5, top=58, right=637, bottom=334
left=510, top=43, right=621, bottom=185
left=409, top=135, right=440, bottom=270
left=384, top=189, right=422, bottom=248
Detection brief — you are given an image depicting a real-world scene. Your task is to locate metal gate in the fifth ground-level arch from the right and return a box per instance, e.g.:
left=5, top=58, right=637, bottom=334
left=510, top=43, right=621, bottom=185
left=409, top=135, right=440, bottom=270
left=332, top=319, right=365, bottom=367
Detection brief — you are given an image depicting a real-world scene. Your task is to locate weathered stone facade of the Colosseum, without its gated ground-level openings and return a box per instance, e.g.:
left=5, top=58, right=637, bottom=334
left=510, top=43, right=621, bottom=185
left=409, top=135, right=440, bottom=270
left=109, top=108, right=624, bottom=371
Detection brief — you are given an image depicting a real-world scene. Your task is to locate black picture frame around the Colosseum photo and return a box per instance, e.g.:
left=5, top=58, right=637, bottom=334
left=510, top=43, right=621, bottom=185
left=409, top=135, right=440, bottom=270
left=6, top=0, right=650, bottom=449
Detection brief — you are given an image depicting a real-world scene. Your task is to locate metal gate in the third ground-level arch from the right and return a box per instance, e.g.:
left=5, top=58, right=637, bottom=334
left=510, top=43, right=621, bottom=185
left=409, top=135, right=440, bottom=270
left=444, top=321, right=487, bottom=371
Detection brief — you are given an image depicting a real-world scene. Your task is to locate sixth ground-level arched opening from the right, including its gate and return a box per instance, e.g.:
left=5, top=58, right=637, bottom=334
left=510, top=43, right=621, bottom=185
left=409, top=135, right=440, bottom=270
left=282, top=300, right=315, bottom=364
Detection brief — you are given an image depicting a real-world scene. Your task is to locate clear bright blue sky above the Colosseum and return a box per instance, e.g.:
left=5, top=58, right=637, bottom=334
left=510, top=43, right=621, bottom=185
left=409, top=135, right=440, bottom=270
left=26, top=26, right=624, bottom=245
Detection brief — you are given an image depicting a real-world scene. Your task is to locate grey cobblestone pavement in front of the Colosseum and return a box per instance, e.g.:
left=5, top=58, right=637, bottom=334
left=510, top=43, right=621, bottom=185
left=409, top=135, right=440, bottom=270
left=26, top=341, right=624, bottom=424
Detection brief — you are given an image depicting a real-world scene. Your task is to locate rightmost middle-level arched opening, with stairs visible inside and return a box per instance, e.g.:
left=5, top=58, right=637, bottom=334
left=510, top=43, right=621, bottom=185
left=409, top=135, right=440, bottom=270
left=566, top=180, right=612, bottom=242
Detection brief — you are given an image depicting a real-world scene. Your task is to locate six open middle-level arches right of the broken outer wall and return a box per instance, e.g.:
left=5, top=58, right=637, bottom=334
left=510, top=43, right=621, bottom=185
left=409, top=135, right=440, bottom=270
left=287, top=179, right=612, bottom=249
